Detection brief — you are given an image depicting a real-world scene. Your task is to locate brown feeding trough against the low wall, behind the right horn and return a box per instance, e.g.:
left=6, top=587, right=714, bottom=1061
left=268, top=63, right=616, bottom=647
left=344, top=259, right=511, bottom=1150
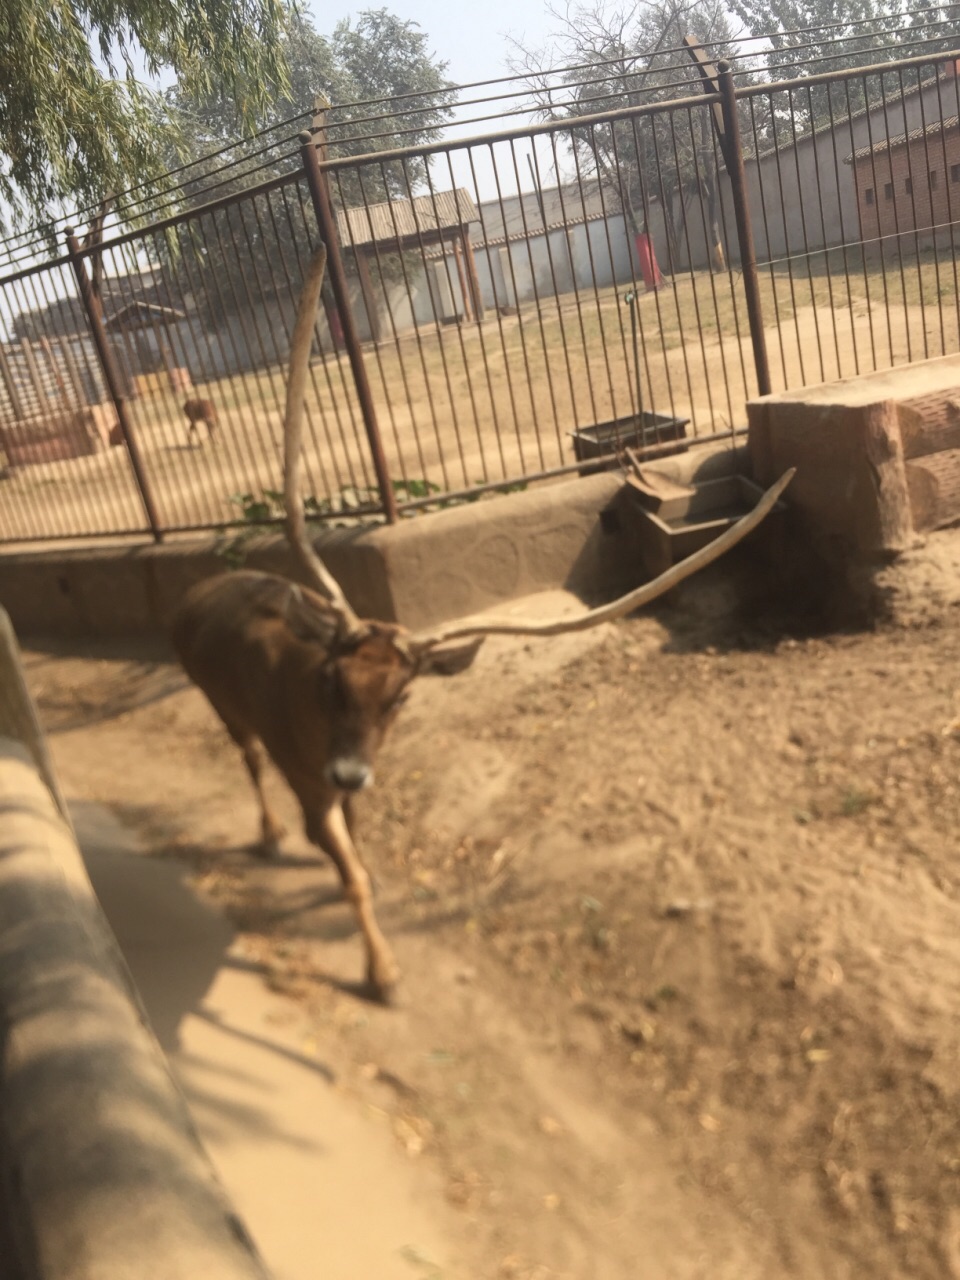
left=628, top=475, right=786, bottom=577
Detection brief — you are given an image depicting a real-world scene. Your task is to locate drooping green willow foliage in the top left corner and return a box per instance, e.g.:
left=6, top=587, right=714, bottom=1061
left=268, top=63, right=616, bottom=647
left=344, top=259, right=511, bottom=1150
left=0, top=0, right=288, bottom=225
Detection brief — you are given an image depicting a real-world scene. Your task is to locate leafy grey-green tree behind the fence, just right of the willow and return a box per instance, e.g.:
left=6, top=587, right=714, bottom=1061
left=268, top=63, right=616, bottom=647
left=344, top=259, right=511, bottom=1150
left=170, top=9, right=454, bottom=317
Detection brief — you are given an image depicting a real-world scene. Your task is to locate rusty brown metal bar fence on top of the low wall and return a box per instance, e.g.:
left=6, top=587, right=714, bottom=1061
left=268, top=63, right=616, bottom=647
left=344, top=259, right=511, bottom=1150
left=0, top=45, right=960, bottom=544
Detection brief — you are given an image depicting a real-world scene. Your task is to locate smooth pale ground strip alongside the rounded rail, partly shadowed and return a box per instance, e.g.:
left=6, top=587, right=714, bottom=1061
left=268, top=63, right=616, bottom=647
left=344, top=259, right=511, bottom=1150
left=73, top=801, right=458, bottom=1280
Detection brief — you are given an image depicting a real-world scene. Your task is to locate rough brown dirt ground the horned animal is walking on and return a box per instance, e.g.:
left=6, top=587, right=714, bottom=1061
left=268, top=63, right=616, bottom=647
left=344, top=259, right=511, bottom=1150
left=22, top=534, right=960, bottom=1280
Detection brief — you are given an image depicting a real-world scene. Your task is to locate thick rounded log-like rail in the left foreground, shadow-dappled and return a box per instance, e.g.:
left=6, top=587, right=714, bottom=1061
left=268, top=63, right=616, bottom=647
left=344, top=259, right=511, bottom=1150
left=0, top=618, right=273, bottom=1280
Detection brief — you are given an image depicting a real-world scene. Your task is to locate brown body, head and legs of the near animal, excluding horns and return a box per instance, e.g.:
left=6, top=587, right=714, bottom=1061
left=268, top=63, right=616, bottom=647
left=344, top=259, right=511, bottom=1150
left=172, top=571, right=480, bottom=997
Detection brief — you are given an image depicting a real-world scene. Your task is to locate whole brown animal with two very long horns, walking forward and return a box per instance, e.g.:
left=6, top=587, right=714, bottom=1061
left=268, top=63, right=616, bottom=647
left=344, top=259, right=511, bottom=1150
left=172, top=244, right=792, bottom=1002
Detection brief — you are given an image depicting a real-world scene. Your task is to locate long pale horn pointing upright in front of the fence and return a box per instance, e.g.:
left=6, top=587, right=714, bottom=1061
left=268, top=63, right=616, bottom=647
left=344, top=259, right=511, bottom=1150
left=283, top=244, right=364, bottom=635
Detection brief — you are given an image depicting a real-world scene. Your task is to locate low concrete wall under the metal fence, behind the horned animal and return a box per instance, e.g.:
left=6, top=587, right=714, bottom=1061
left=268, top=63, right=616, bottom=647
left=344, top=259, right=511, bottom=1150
left=0, top=472, right=641, bottom=635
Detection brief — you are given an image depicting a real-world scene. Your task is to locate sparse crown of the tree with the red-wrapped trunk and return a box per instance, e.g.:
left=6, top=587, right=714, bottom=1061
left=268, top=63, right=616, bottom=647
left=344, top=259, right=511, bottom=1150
left=515, top=0, right=732, bottom=265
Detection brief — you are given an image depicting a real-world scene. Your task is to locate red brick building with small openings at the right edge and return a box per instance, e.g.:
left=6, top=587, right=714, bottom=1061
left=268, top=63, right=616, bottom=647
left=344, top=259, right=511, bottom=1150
left=846, top=115, right=960, bottom=247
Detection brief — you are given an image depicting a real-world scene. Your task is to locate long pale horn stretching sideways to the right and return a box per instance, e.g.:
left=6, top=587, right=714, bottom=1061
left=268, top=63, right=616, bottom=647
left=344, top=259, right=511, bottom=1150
left=413, top=467, right=796, bottom=649
